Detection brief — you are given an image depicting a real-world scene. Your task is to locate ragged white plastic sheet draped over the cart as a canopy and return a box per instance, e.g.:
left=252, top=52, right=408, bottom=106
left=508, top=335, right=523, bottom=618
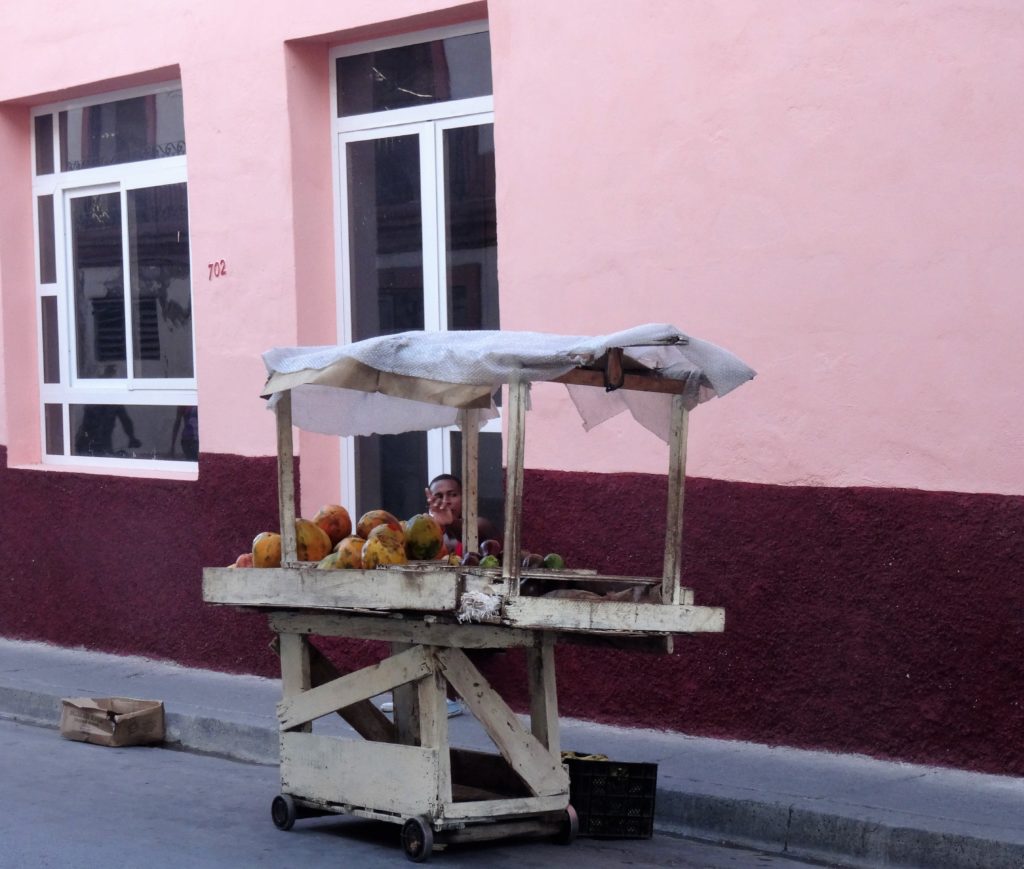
left=263, top=323, right=755, bottom=441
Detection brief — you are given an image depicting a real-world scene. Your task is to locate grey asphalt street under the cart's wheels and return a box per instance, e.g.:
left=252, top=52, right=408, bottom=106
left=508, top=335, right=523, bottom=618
left=0, top=721, right=839, bottom=869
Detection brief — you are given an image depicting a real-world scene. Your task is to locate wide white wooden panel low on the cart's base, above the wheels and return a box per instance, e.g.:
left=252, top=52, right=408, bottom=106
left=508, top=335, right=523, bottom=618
left=281, top=733, right=440, bottom=817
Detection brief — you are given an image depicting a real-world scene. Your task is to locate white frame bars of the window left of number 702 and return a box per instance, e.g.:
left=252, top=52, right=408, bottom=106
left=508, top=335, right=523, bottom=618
left=31, top=82, right=199, bottom=476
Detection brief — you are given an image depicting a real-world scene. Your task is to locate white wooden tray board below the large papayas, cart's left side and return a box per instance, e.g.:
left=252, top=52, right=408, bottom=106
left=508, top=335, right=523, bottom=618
left=203, top=560, right=458, bottom=611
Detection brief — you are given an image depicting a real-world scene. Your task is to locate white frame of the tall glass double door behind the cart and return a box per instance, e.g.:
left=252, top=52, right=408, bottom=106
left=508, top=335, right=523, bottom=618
left=329, top=20, right=502, bottom=505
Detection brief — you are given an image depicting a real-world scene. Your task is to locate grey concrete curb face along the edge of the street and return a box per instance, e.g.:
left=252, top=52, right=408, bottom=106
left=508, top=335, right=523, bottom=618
left=0, top=687, right=1024, bottom=869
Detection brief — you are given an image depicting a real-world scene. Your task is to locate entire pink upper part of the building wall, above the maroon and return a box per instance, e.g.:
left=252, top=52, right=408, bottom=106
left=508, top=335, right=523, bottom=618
left=0, top=0, right=1024, bottom=505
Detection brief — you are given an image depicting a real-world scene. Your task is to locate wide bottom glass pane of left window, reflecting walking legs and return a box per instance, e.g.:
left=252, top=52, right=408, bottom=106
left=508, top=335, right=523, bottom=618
left=70, top=404, right=199, bottom=462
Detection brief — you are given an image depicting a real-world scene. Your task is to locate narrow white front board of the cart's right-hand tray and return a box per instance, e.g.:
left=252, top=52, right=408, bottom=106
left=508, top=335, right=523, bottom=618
left=505, top=597, right=725, bottom=634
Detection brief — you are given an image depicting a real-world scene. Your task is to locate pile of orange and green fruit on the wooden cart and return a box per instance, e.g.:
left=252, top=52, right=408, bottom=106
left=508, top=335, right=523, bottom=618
left=228, top=504, right=565, bottom=570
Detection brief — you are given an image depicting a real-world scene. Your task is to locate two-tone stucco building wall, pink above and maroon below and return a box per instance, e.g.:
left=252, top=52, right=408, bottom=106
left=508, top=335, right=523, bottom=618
left=0, top=0, right=1024, bottom=775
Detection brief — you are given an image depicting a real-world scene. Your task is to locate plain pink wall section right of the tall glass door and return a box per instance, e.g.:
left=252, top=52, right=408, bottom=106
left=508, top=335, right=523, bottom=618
left=490, top=0, right=1024, bottom=493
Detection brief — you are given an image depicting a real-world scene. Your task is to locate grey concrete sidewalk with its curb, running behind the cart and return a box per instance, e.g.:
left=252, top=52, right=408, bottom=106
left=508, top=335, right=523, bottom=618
left=0, top=639, right=1024, bottom=869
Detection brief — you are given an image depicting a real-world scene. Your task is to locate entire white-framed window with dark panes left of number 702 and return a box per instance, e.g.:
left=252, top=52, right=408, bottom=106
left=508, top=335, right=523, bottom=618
left=33, top=85, right=199, bottom=469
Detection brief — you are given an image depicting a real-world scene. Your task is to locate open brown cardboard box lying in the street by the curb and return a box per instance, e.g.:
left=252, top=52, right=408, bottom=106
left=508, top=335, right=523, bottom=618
left=60, top=697, right=164, bottom=747
